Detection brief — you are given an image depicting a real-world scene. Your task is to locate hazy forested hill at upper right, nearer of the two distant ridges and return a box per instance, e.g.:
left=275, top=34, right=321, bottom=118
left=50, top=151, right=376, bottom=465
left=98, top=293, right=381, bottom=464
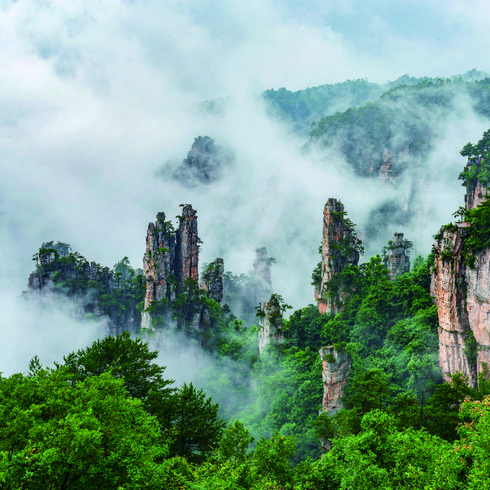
left=307, top=78, right=490, bottom=176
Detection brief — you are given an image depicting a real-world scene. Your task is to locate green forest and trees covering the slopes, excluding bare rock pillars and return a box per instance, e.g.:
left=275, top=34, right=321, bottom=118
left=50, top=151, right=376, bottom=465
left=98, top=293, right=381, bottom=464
left=4, top=83, right=490, bottom=490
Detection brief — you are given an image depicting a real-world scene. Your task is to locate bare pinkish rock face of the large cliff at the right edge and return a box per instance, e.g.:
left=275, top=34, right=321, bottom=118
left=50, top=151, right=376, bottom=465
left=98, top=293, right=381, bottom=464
left=431, top=173, right=490, bottom=385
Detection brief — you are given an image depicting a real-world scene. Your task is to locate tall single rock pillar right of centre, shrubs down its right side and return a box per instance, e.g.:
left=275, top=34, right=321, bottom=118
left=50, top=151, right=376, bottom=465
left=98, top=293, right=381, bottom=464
left=316, top=198, right=359, bottom=314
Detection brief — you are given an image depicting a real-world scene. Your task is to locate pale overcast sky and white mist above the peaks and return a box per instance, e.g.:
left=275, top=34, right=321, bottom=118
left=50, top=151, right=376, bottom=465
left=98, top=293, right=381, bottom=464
left=0, top=0, right=490, bottom=371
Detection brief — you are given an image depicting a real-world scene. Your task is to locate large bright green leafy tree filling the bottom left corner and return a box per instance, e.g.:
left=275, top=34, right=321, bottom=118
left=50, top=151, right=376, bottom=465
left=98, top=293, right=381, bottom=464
left=0, top=368, right=168, bottom=490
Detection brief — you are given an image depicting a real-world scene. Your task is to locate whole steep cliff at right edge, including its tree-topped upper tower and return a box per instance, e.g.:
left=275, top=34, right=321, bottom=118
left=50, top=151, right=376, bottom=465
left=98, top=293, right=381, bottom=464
left=431, top=151, right=490, bottom=385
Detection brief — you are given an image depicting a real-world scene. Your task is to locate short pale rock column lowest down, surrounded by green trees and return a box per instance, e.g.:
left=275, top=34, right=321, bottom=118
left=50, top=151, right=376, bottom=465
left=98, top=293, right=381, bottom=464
left=320, top=345, right=352, bottom=414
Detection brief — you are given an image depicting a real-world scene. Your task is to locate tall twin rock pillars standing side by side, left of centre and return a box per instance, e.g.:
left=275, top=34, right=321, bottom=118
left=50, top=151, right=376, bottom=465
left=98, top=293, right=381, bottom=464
left=141, top=204, right=201, bottom=329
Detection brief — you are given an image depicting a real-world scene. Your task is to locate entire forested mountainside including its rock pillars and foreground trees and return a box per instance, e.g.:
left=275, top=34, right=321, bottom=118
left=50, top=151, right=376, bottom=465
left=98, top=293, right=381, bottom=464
left=7, top=81, right=490, bottom=490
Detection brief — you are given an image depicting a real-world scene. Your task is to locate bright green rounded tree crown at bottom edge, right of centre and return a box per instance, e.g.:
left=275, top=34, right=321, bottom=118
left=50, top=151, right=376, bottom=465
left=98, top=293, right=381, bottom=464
left=318, top=410, right=461, bottom=490
